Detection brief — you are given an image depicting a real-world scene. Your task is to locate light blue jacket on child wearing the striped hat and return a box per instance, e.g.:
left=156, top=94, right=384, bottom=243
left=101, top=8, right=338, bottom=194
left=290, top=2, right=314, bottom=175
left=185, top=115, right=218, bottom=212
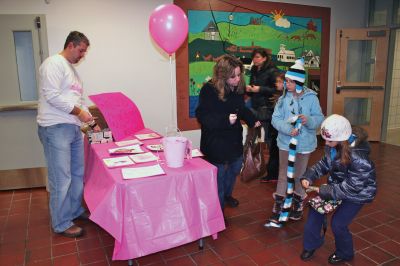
left=272, top=87, right=324, bottom=153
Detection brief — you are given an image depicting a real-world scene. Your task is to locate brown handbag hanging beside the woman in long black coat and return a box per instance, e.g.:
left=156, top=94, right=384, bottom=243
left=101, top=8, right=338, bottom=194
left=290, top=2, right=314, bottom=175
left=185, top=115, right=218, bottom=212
left=240, top=127, right=267, bottom=182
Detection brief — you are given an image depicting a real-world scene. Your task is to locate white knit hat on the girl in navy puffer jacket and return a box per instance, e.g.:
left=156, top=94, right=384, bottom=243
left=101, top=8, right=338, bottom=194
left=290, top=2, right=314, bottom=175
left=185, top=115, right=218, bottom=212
left=321, top=114, right=352, bottom=141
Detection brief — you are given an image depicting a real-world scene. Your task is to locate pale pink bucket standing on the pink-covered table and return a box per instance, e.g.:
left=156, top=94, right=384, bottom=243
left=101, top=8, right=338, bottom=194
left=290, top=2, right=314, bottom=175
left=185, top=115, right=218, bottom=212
left=162, top=137, right=192, bottom=168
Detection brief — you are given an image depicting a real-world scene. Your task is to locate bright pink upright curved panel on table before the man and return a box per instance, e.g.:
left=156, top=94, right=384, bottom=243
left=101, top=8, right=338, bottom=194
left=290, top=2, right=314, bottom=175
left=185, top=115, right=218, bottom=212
left=89, top=92, right=144, bottom=141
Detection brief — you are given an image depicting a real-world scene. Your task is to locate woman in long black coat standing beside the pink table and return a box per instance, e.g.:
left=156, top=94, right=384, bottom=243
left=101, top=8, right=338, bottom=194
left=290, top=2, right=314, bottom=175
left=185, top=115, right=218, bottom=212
left=196, top=55, right=261, bottom=209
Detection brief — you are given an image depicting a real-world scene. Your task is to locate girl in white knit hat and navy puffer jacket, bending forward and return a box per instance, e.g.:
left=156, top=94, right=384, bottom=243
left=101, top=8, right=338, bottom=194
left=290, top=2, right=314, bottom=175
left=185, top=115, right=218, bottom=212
left=300, top=114, right=376, bottom=264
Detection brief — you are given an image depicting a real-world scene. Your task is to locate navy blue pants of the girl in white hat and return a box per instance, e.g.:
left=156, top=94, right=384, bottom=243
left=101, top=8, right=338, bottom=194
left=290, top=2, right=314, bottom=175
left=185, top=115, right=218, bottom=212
left=303, top=201, right=363, bottom=260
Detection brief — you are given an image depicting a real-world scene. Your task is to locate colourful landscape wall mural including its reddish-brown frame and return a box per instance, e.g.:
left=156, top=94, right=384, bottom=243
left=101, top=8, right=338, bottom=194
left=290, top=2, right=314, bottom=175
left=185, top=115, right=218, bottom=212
left=174, top=0, right=330, bottom=130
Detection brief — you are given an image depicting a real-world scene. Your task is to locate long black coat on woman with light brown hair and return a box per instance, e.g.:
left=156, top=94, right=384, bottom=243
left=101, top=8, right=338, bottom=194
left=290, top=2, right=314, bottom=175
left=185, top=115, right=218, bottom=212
left=196, top=82, right=256, bottom=163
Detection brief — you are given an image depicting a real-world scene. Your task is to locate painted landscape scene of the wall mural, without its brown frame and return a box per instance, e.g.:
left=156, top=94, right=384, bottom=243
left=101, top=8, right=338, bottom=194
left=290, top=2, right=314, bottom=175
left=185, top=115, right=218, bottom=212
left=188, top=10, right=321, bottom=118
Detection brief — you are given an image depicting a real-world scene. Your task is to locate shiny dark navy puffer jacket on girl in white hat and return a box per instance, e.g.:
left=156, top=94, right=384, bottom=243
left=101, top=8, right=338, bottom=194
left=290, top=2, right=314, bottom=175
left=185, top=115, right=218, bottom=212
left=301, top=133, right=376, bottom=203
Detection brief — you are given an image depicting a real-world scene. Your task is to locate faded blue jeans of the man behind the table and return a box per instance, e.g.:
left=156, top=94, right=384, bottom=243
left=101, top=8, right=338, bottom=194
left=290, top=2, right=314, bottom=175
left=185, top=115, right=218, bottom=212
left=38, top=124, right=84, bottom=233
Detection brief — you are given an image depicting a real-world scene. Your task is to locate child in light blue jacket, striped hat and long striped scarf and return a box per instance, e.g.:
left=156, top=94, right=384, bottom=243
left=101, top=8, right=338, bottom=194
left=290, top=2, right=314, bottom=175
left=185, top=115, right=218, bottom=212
left=265, top=59, right=324, bottom=227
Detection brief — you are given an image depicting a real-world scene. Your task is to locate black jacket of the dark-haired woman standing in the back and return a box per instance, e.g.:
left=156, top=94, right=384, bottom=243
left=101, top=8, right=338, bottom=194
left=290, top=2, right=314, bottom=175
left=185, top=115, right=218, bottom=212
left=247, top=63, right=278, bottom=117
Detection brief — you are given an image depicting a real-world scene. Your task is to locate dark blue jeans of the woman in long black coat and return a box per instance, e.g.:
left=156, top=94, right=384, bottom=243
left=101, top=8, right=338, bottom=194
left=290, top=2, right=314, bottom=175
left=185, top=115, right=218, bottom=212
left=213, top=156, right=243, bottom=209
